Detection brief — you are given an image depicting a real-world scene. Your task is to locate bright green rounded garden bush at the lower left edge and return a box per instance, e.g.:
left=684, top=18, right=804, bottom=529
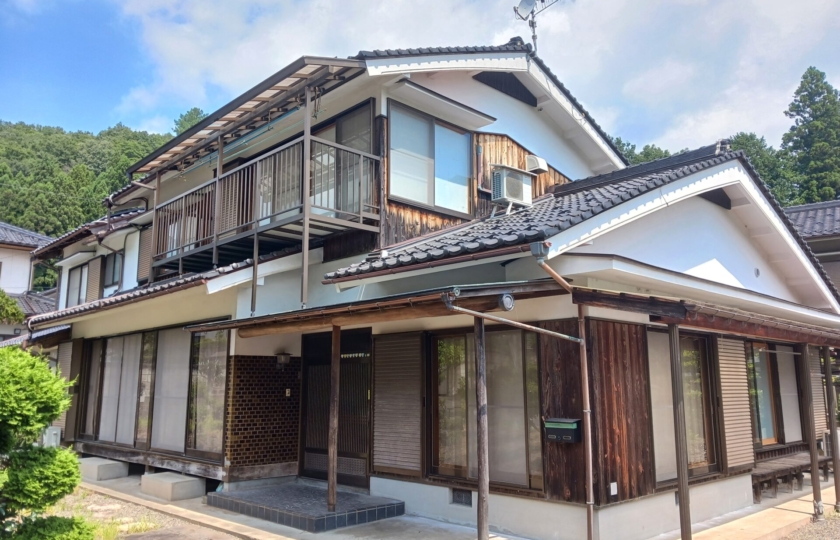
left=0, top=347, right=93, bottom=540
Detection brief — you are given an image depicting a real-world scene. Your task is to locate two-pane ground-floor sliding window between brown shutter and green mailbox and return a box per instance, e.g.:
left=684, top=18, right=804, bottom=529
left=432, top=330, right=542, bottom=489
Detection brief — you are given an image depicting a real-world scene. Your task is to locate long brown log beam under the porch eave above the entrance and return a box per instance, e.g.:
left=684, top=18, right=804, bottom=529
left=238, top=297, right=499, bottom=338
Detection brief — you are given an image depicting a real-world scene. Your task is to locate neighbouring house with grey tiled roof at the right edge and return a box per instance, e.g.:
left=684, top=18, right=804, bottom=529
left=785, top=200, right=840, bottom=283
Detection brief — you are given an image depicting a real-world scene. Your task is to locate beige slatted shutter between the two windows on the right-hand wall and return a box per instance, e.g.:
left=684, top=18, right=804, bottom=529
left=717, top=338, right=755, bottom=470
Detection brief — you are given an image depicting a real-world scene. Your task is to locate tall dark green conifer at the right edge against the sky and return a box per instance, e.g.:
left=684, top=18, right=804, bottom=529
left=782, top=66, right=840, bottom=203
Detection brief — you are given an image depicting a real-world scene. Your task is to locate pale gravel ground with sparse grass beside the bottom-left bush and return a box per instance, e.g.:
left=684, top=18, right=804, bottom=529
left=48, top=488, right=233, bottom=540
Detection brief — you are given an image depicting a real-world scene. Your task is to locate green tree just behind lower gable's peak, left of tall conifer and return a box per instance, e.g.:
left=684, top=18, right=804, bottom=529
left=730, top=132, right=799, bottom=206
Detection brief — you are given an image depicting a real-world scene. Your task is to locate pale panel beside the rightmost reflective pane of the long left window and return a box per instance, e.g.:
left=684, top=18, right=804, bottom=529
left=152, top=328, right=191, bottom=452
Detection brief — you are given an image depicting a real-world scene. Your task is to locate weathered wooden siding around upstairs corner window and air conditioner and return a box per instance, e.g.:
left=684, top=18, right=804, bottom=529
left=377, top=133, right=570, bottom=247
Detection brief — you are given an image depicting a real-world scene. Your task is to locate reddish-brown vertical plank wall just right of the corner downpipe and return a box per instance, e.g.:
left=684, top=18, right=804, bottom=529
left=587, top=319, right=656, bottom=505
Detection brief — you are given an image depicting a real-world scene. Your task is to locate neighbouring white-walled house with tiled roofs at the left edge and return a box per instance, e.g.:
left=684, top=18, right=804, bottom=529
left=0, top=221, right=55, bottom=341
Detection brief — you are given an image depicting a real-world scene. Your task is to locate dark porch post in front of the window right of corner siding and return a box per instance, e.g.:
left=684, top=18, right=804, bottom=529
left=668, top=324, right=691, bottom=540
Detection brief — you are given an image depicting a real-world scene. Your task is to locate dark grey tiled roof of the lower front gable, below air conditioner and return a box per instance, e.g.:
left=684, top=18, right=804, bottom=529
left=324, top=143, right=840, bottom=308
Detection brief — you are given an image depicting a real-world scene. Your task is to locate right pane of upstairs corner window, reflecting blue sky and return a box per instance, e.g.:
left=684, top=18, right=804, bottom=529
left=435, top=125, right=471, bottom=214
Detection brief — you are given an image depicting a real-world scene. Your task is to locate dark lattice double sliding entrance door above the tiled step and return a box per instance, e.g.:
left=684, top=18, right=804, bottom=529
left=300, top=329, right=371, bottom=487
